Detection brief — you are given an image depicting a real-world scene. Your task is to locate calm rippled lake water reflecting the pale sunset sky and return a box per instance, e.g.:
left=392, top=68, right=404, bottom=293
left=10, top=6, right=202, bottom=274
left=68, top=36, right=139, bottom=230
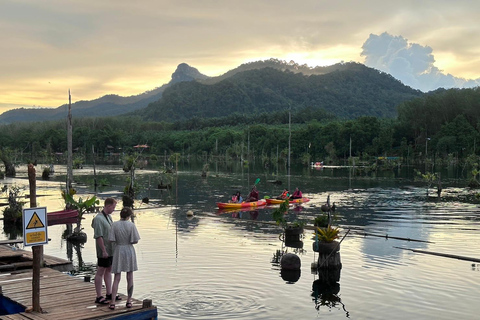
left=2, top=165, right=480, bottom=320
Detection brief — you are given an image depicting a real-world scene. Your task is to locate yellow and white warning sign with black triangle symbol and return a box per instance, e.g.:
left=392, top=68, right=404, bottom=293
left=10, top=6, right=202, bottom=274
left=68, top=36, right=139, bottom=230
left=23, top=207, right=48, bottom=246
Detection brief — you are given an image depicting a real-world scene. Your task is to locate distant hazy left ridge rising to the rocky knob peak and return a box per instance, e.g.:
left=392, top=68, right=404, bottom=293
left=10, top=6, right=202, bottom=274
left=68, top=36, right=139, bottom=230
left=0, top=63, right=208, bottom=124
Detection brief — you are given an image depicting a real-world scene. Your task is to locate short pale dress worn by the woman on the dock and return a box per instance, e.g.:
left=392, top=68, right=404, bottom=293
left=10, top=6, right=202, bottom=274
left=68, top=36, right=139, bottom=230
left=109, top=220, right=140, bottom=273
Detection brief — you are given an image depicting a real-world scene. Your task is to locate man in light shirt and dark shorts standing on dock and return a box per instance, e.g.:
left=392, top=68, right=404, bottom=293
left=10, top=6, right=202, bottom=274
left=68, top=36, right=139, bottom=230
left=92, top=198, right=117, bottom=304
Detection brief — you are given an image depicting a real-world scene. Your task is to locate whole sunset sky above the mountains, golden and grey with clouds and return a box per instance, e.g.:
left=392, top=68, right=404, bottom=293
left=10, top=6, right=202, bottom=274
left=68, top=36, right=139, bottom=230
left=0, top=0, right=480, bottom=113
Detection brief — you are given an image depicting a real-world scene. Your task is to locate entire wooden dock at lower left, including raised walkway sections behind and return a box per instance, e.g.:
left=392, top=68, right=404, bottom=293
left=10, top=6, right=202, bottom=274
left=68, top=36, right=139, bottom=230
left=0, top=245, right=157, bottom=320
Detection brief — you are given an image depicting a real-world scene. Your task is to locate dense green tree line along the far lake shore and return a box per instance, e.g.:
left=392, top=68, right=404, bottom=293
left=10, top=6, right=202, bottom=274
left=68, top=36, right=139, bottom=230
left=0, top=88, right=480, bottom=170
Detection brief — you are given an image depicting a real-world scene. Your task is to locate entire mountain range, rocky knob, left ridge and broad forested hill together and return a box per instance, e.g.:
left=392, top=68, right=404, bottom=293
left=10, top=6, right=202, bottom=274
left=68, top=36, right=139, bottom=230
left=0, top=59, right=422, bottom=124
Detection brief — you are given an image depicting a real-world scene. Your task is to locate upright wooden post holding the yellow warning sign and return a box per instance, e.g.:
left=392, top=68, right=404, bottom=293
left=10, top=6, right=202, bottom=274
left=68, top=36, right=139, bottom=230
left=28, top=163, right=43, bottom=312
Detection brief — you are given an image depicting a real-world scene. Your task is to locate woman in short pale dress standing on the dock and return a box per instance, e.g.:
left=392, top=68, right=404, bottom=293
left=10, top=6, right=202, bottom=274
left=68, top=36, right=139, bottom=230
left=109, top=207, right=140, bottom=310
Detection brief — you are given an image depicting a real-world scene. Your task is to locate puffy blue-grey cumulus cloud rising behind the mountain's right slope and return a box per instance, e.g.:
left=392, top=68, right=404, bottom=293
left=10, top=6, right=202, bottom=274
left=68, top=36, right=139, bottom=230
left=361, top=32, right=480, bottom=92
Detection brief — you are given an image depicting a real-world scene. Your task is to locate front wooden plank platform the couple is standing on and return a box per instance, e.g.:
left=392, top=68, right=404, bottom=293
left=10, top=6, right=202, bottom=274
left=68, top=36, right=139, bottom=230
left=0, top=268, right=157, bottom=320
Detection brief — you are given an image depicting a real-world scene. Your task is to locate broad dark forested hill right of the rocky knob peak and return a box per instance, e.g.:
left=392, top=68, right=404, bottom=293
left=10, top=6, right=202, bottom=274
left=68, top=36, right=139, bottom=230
left=136, top=63, right=423, bottom=121
